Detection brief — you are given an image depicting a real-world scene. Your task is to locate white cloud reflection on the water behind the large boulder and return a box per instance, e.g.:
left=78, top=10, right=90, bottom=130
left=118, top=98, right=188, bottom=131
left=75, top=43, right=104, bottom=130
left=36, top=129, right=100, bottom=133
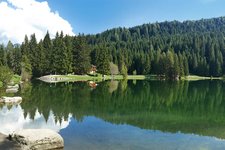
left=0, top=105, right=70, bottom=135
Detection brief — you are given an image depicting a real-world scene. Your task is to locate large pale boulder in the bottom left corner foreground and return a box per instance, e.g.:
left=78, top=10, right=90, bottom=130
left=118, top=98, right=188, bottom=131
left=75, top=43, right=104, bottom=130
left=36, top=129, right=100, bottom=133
left=9, top=129, right=64, bottom=150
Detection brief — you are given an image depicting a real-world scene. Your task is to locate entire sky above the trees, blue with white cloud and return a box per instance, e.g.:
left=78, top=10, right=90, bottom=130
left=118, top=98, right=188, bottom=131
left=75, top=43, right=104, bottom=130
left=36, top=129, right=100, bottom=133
left=0, top=0, right=225, bottom=43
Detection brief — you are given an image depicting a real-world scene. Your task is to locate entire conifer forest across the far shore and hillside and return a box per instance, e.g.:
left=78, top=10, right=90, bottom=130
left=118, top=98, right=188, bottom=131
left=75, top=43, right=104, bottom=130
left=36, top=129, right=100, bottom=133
left=0, top=17, right=225, bottom=78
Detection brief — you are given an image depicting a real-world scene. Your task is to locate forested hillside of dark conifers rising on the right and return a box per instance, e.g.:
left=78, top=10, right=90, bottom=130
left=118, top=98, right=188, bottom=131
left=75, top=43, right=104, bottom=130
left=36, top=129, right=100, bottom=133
left=87, top=17, right=225, bottom=76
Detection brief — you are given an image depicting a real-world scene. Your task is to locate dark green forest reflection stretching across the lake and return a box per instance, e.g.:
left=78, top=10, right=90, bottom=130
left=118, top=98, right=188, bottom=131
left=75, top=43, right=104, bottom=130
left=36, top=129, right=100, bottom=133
left=16, top=81, right=225, bottom=138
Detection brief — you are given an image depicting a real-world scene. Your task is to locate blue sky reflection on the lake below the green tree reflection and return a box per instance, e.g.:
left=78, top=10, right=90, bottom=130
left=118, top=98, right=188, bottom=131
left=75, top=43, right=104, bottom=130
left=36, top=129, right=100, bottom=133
left=60, top=117, right=225, bottom=150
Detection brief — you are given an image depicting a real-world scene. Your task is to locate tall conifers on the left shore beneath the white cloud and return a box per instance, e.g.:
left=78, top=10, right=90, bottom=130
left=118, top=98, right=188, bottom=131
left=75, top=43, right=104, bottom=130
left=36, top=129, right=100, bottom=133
left=0, top=32, right=91, bottom=79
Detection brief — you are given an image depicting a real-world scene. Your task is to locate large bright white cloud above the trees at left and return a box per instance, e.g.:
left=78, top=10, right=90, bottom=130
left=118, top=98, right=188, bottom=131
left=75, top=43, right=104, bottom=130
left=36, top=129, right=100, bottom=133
left=0, top=0, right=74, bottom=43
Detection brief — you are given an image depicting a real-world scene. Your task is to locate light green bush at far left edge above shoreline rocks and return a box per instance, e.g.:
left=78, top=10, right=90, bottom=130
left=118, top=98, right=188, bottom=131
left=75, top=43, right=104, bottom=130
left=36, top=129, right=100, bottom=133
left=0, top=66, right=13, bottom=86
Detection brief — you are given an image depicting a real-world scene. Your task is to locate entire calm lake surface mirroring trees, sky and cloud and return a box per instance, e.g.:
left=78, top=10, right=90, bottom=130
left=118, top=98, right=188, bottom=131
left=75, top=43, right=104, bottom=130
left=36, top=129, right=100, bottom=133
left=0, top=81, right=225, bottom=150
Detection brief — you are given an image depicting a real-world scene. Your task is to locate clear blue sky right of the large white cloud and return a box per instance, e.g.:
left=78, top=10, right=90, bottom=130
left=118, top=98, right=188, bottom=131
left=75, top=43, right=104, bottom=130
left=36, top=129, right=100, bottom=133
left=40, top=0, right=225, bottom=34
